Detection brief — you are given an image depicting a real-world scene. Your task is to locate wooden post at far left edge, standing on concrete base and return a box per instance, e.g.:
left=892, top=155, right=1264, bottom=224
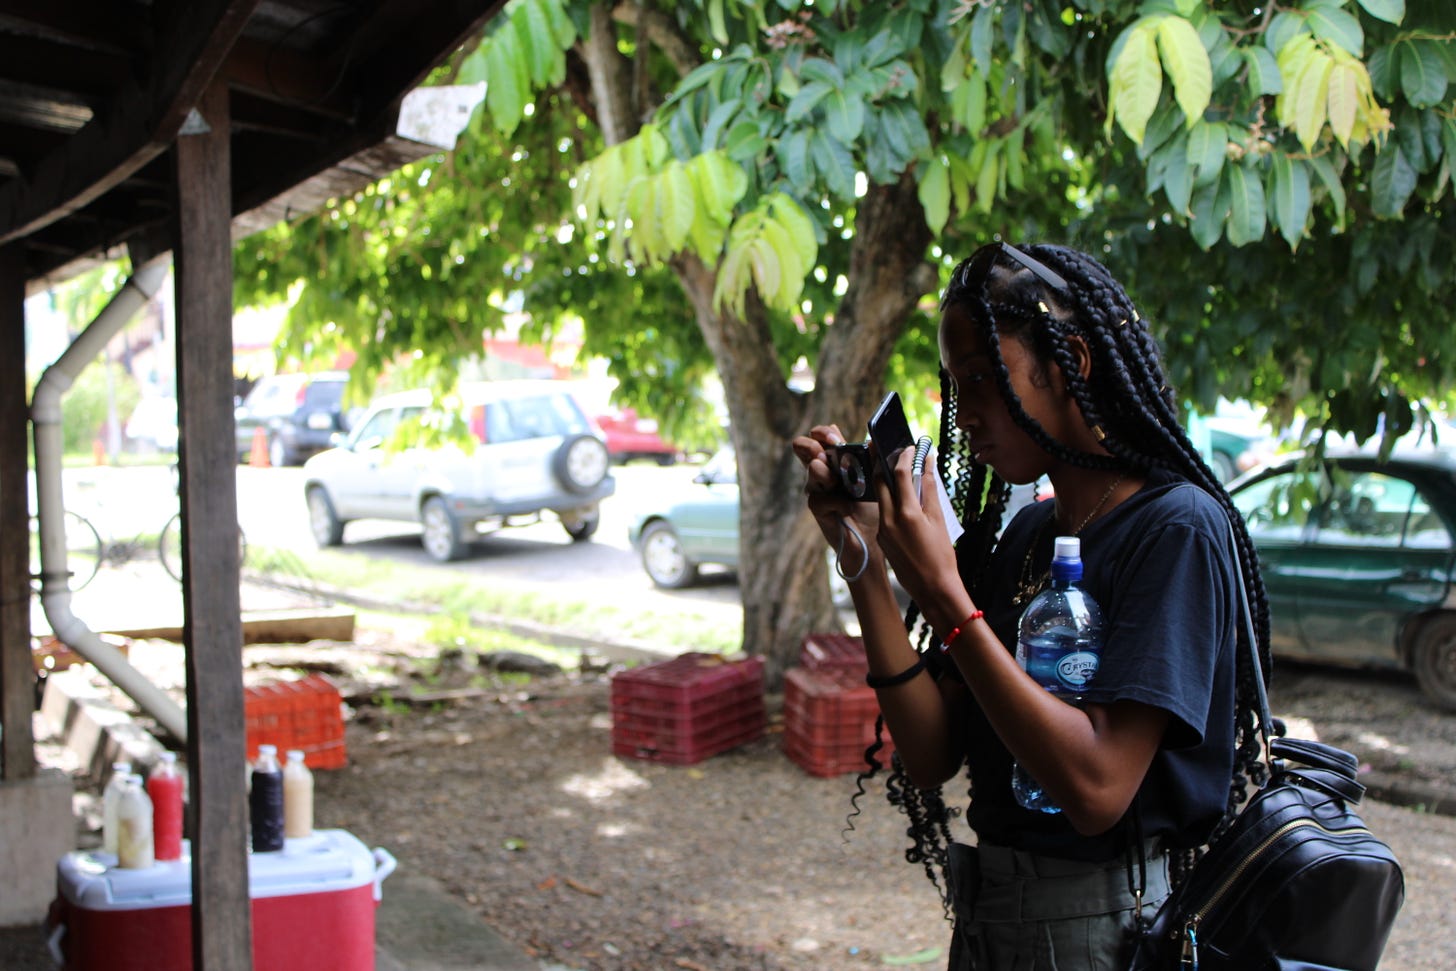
left=0, top=246, right=35, bottom=782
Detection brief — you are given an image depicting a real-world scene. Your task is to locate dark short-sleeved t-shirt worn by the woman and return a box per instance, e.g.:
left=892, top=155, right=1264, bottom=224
left=943, top=472, right=1239, bottom=860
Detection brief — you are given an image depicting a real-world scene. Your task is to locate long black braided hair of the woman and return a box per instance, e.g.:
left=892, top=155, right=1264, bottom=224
left=850, top=243, right=1270, bottom=911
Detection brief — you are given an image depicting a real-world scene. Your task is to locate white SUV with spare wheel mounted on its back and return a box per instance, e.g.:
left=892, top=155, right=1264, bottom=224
left=303, top=381, right=616, bottom=560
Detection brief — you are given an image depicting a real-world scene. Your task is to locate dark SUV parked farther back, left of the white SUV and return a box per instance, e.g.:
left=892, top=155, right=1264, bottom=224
left=234, top=371, right=351, bottom=466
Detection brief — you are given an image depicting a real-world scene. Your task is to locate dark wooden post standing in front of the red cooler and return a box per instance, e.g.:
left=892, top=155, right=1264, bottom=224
left=173, top=82, right=253, bottom=971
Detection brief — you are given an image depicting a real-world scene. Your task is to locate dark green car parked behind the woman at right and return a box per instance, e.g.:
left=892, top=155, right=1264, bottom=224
left=1230, top=448, right=1456, bottom=710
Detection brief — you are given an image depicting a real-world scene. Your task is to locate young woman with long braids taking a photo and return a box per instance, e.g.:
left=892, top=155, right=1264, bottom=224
left=794, top=243, right=1268, bottom=970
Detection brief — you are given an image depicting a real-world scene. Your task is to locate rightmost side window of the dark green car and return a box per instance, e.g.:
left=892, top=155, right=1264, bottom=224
left=1318, top=472, right=1450, bottom=549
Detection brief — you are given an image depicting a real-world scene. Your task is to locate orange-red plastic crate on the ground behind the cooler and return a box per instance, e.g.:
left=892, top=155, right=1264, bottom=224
left=243, top=674, right=348, bottom=769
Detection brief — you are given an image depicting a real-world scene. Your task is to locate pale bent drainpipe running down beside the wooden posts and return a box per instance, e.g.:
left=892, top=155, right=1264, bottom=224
left=31, top=256, right=186, bottom=741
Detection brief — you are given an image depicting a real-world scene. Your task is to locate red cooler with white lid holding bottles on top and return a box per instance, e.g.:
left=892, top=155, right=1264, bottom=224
left=51, top=830, right=396, bottom=971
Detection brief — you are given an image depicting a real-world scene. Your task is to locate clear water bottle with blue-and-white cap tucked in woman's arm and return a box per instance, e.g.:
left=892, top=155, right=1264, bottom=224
left=1010, top=536, right=1102, bottom=812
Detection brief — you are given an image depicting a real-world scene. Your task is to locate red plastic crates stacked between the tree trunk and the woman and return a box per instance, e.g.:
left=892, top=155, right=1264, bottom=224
left=783, top=633, right=894, bottom=776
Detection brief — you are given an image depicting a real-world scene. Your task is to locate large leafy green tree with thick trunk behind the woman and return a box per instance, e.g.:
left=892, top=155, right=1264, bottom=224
left=239, top=0, right=1456, bottom=684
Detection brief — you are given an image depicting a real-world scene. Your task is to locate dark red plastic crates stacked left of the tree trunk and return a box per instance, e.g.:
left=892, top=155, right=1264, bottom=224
left=612, top=652, right=767, bottom=766
